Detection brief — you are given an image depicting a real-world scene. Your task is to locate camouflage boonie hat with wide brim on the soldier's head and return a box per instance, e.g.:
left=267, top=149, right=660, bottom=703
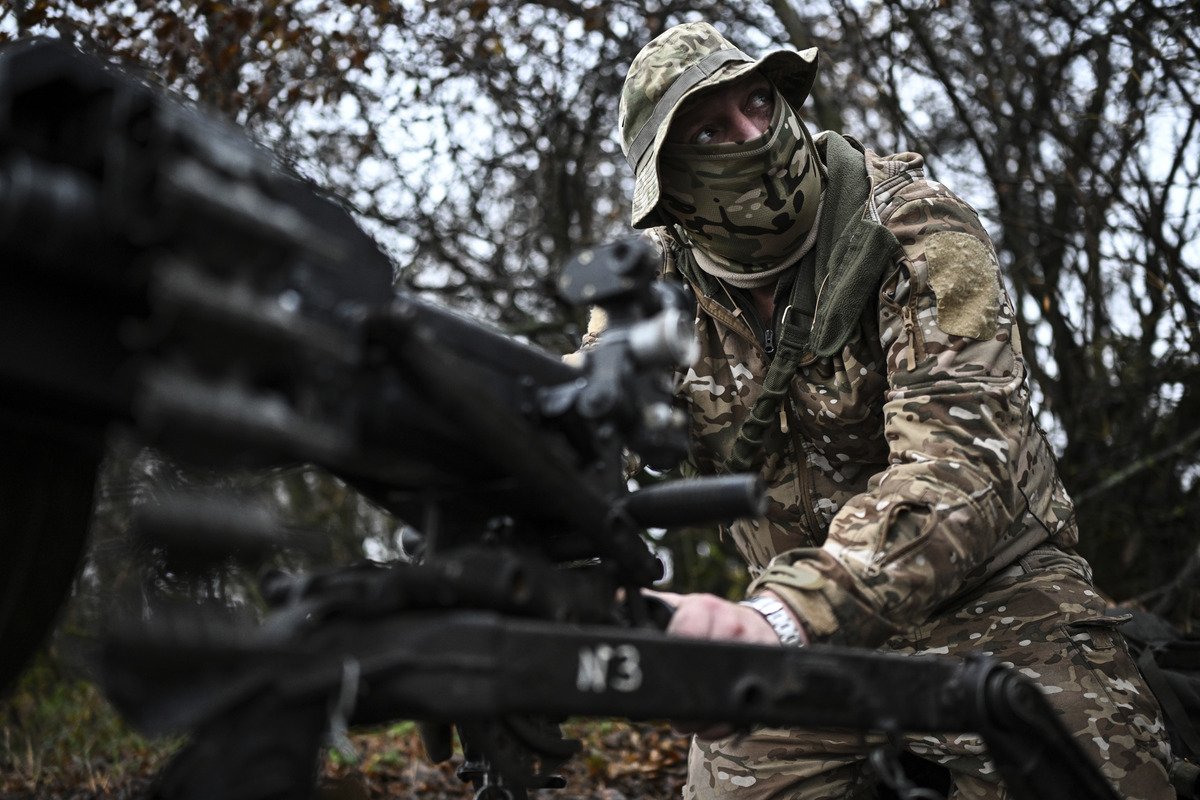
left=619, top=23, right=817, bottom=228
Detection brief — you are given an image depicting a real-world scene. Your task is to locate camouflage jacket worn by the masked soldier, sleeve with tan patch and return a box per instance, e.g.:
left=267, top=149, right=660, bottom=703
left=609, top=137, right=1078, bottom=646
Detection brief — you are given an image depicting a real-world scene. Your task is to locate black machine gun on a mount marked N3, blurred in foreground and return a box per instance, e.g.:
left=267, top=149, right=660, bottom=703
left=0, top=42, right=1115, bottom=800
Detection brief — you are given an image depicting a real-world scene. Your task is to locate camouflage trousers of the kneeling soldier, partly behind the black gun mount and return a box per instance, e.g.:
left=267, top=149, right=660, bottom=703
left=684, top=548, right=1175, bottom=800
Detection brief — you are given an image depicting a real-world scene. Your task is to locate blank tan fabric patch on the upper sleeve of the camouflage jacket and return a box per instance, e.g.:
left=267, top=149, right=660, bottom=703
left=925, top=231, right=1000, bottom=339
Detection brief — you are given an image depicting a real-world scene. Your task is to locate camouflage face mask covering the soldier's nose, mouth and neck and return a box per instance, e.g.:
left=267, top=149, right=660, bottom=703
left=659, top=91, right=823, bottom=277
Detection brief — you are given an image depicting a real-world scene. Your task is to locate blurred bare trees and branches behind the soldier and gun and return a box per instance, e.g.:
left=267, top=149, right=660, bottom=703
left=0, top=0, right=1200, bottom=796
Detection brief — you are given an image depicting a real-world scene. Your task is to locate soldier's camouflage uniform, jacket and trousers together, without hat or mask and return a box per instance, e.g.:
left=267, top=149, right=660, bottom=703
left=628, top=136, right=1172, bottom=798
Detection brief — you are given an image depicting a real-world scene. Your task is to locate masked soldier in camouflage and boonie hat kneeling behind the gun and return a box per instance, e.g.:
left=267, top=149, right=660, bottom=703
left=595, top=23, right=1174, bottom=800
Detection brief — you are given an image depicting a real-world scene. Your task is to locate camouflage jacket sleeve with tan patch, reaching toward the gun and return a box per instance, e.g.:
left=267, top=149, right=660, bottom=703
left=751, top=184, right=1032, bottom=646
